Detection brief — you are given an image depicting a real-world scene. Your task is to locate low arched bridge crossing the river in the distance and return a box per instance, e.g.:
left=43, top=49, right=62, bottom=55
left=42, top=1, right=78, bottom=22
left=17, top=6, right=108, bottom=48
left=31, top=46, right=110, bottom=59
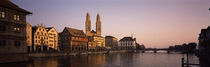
left=138, top=48, right=173, bottom=53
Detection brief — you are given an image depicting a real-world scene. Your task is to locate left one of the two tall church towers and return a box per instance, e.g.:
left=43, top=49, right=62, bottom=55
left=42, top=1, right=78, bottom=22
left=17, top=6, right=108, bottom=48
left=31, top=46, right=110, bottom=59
left=85, top=12, right=91, bottom=36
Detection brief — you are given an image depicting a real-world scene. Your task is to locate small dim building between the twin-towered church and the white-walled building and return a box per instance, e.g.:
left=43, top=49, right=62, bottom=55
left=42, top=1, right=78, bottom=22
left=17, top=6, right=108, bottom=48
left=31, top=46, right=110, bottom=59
left=105, top=36, right=118, bottom=49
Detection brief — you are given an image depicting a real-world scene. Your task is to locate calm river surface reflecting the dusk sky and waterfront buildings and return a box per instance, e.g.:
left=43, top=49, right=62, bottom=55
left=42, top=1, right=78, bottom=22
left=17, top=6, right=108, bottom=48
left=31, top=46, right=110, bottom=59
left=0, top=53, right=199, bottom=67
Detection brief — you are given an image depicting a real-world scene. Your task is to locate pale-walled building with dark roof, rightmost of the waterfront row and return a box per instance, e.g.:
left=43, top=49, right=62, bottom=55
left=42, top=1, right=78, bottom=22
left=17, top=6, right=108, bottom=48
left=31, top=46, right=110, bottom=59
left=119, top=37, right=136, bottom=49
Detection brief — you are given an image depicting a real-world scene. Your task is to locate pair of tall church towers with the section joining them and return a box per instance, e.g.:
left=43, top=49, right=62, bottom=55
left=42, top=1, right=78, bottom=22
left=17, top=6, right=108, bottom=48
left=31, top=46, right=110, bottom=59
left=85, top=12, right=101, bottom=36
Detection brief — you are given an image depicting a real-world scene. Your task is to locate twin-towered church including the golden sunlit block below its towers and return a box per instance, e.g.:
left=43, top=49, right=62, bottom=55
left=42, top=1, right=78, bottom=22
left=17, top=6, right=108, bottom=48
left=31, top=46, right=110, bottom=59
left=85, top=12, right=105, bottom=51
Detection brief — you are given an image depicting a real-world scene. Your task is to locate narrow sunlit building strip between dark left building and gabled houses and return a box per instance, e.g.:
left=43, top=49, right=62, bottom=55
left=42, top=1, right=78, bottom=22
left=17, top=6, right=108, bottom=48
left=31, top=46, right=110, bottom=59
left=26, top=22, right=32, bottom=52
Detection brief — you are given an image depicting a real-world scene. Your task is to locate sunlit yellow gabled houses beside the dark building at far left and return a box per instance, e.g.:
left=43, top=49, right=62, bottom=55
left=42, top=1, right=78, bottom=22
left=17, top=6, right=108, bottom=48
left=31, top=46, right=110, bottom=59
left=26, top=23, right=58, bottom=52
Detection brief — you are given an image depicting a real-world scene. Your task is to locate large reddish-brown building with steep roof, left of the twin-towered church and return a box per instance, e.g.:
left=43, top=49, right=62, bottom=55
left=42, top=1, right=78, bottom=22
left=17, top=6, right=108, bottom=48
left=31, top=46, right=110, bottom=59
left=59, top=27, right=88, bottom=52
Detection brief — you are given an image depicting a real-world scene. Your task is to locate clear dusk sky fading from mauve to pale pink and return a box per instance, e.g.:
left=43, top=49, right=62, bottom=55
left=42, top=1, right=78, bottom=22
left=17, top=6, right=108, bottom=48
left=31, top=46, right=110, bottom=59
left=10, top=0, right=210, bottom=48
